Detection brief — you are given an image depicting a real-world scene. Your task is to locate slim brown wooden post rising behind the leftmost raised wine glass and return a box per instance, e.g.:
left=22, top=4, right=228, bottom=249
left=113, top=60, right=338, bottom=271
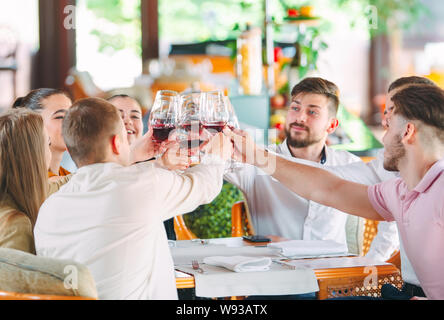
left=141, top=0, right=159, bottom=62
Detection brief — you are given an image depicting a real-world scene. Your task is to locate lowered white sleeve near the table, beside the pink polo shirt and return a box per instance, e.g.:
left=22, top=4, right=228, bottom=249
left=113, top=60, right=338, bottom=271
left=366, top=221, right=399, bottom=261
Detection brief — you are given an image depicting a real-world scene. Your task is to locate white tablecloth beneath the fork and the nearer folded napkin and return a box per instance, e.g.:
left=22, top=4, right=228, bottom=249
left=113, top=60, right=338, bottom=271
left=170, top=239, right=319, bottom=297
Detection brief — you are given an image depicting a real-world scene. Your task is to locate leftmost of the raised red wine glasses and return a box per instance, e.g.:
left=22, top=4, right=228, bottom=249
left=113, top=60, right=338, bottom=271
left=150, top=90, right=179, bottom=144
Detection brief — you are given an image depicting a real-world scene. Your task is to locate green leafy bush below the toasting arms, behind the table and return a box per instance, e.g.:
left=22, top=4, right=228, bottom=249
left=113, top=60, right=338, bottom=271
left=184, top=182, right=243, bottom=239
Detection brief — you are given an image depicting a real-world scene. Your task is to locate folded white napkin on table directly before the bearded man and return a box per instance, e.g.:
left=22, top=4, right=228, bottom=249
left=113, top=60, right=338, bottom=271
left=268, top=240, right=348, bottom=257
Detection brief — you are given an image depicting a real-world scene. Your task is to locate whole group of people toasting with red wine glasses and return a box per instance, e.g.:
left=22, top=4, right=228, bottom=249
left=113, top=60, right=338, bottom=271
left=0, top=77, right=444, bottom=299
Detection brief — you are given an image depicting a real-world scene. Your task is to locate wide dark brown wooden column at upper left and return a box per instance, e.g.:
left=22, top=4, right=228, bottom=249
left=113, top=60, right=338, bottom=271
left=35, top=0, right=76, bottom=88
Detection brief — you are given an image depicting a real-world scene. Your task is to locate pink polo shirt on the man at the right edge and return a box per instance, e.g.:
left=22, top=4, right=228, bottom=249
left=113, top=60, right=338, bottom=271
left=368, top=160, right=444, bottom=299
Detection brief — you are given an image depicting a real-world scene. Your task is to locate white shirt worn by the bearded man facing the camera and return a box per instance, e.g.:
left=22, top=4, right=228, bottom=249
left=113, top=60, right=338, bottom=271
left=224, top=141, right=361, bottom=244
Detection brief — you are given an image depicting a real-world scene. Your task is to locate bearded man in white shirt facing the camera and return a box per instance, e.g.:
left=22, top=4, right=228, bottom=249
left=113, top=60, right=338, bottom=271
left=224, top=78, right=398, bottom=260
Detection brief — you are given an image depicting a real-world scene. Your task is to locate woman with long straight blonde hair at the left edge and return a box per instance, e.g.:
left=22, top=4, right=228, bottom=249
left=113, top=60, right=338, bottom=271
left=0, top=109, right=69, bottom=254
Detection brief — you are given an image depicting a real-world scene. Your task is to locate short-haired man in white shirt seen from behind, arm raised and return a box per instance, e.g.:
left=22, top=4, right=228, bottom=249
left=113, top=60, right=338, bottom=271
left=34, top=99, right=232, bottom=300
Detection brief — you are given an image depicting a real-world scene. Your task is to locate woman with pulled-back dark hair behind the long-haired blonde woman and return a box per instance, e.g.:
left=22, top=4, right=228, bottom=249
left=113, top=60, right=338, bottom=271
left=13, top=88, right=72, bottom=177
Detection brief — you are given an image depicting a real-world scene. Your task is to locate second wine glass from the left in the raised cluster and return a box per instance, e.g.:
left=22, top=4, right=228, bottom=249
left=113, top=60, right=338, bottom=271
left=177, top=92, right=205, bottom=164
